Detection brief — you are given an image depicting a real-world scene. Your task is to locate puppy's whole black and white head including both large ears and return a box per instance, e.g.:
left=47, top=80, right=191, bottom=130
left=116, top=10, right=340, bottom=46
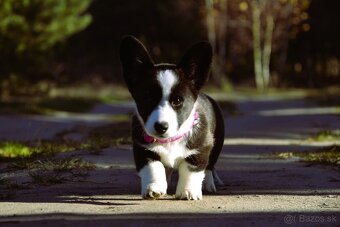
left=120, top=36, right=212, bottom=138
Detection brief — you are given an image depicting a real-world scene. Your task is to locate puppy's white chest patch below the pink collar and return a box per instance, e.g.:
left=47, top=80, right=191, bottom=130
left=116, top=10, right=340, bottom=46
left=148, top=142, right=197, bottom=168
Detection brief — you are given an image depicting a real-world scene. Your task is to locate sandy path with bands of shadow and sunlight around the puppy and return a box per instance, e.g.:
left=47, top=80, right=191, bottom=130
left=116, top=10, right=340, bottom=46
left=0, top=94, right=340, bottom=226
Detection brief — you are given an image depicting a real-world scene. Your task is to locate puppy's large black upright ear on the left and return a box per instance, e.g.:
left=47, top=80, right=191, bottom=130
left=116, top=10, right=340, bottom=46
left=120, top=36, right=153, bottom=84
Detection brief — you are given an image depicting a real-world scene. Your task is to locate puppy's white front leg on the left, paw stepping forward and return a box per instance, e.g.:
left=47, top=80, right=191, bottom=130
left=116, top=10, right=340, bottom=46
left=139, top=161, right=168, bottom=199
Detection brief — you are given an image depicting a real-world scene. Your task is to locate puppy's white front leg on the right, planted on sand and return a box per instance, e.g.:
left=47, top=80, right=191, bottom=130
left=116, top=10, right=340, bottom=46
left=176, top=161, right=204, bottom=200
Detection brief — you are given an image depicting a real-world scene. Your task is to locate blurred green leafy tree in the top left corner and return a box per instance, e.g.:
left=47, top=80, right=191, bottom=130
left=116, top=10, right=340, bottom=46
left=0, top=0, right=92, bottom=85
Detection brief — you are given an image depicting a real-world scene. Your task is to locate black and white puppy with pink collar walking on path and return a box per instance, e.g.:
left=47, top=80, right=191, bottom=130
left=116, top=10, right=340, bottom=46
left=120, top=36, right=224, bottom=200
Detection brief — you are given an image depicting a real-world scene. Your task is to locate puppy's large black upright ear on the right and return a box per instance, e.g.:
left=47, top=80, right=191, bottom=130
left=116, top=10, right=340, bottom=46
left=177, top=42, right=213, bottom=90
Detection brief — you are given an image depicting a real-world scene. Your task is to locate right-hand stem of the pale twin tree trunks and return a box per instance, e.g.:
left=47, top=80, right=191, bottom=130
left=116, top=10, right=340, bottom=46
left=262, top=15, right=274, bottom=89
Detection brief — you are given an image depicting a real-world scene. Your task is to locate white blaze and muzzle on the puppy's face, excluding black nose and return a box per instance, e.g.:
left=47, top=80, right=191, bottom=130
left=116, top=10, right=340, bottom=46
left=145, top=70, right=178, bottom=138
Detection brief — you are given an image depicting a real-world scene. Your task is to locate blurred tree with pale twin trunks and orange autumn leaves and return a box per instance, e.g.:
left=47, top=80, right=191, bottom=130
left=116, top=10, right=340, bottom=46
left=229, top=0, right=310, bottom=90
